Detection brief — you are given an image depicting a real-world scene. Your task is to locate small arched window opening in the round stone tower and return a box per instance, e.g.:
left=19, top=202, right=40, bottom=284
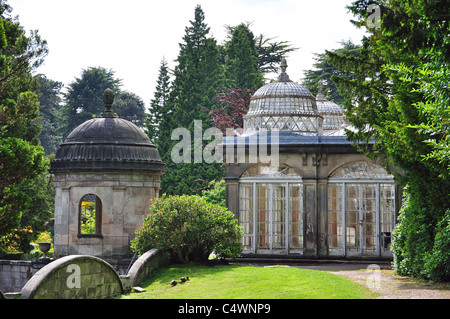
left=78, top=194, right=102, bottom=236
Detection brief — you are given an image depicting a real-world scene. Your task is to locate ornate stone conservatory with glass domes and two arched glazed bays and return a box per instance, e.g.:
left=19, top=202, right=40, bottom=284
left=223, top=60, right=401, bottom=259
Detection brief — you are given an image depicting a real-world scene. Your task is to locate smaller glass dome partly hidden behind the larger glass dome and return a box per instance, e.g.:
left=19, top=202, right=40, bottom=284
left=316, top=80, right=346, bottom=131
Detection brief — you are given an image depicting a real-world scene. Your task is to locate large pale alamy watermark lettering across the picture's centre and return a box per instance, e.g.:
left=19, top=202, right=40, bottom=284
left=170, top=120, right=279, bottom=164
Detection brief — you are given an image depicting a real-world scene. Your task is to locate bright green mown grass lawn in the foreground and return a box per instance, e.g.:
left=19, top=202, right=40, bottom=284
left=122, top=264, right=370, bottom=299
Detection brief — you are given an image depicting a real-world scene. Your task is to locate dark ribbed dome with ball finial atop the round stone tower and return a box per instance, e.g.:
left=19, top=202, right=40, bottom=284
left=50, top=89, right=164, bottom=173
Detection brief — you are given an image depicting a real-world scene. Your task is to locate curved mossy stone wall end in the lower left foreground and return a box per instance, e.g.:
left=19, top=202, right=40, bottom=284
left=22, top=255, right=123, bottom=299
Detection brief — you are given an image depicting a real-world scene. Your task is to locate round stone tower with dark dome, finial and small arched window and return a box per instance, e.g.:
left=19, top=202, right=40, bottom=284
left=50, top=89, right=164, bottom=260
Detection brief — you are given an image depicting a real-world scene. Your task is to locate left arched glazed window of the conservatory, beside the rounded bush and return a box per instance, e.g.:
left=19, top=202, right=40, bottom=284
left=239, top=164, right=303, bottom=254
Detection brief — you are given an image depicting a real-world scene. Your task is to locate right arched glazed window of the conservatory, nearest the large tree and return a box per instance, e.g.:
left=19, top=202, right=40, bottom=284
left=328, top=162, right=396, bottom=255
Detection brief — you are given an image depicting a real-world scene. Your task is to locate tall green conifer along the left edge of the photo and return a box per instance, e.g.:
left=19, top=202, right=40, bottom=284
left=0, top=1, right=47, bottom=250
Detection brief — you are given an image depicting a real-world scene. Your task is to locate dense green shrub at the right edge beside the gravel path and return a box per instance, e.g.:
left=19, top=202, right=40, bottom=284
left=392, top=178, right=450, bottom=281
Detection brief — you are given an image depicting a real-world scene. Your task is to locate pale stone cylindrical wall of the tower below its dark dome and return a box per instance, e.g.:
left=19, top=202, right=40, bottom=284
left=54, top=172, right=160, bottom=259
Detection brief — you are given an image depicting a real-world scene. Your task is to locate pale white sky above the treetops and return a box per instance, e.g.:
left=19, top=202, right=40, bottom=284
left=7, top=0, right=364, bottom=107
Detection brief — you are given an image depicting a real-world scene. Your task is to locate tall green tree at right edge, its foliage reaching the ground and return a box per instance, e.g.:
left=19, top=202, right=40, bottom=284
left=328, top=0, right=450, bottom=281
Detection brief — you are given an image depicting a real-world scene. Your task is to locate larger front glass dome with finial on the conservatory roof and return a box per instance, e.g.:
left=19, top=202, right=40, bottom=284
left=244, top=59, right=322, bottom=135
